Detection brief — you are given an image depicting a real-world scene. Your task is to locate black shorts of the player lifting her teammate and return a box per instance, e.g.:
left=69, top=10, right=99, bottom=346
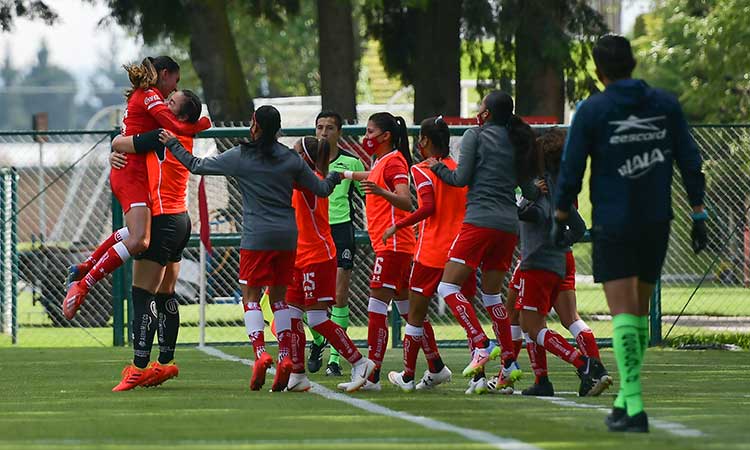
left=135, top=212, right=191, bottom=266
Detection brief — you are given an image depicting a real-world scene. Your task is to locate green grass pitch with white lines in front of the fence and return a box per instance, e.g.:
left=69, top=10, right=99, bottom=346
left=0, top=347, right=750, bottom=450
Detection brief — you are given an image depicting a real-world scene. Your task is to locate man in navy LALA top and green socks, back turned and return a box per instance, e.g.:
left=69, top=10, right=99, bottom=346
left=555, top=35, right=707, bottom=432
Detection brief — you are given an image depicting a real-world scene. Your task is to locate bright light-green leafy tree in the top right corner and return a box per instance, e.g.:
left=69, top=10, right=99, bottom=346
left=633, top=0, right=750, bottom=123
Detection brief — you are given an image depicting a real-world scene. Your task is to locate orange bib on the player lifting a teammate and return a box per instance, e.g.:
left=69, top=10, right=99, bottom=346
left=146, top=136, right=193, bottom=216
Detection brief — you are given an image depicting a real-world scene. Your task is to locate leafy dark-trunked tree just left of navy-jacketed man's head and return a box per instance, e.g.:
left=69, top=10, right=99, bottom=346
left=464, top=0, right=607, bottom=121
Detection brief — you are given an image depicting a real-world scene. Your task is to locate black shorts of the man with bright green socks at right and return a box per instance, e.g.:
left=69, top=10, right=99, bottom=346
left=591, top=222, right=670, bottom=284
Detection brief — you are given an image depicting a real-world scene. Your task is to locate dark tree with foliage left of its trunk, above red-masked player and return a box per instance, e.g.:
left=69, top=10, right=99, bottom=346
left=364, top=0, right=462, bottom=122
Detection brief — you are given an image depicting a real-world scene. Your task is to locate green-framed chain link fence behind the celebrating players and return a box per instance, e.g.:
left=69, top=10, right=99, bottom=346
left=0, top=124, right=750, bottom=347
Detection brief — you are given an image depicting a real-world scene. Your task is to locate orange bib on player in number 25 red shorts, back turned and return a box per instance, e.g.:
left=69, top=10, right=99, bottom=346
left=292, top=183, right=336, bottom=269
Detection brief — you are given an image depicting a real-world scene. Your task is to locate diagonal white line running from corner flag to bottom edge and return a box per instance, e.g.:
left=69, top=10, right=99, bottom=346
left=197, top=347, right=540, bottom=450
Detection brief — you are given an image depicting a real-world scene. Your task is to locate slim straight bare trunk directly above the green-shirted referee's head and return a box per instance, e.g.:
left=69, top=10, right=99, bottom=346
left=317, top=0, right=357, bottom=121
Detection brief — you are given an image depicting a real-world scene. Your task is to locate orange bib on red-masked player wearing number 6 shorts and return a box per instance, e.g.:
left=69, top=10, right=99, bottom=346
left=365, top=150, right=416, bottom=254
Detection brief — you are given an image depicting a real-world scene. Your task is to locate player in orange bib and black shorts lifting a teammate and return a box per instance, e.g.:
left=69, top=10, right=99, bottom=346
left=110, top=90, right=202, bottom=391
